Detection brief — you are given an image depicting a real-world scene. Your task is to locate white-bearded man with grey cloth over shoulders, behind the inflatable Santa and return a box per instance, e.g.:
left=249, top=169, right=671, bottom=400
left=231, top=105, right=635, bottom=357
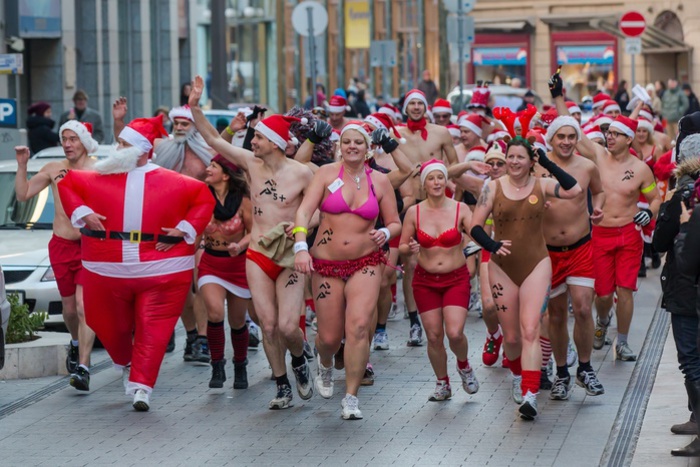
left=112, top=97, right=216, bottom=363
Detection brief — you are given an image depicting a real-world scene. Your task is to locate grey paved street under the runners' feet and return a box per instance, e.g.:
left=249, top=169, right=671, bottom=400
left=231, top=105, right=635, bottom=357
left=0, top=271, right=688, bottom=466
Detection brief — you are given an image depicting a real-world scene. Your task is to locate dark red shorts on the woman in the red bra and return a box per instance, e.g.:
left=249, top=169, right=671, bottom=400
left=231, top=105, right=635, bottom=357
left=412, top=264, right=470, bottom=313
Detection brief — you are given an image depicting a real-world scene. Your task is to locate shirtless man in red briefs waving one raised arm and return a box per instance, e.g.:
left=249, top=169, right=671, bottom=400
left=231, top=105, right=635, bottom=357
left=190, top=76, right=313, bottom=410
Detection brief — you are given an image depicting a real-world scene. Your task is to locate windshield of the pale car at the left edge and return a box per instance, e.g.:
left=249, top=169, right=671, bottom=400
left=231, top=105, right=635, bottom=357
left=0, top=173, right=54, bottom=229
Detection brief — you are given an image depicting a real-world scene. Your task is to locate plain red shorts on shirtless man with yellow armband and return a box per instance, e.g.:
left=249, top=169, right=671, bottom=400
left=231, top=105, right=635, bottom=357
left=591, top=223, right=644, bottom=296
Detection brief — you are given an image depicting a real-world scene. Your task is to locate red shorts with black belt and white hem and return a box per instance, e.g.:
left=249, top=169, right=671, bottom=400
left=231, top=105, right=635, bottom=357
left=547, top=235, right=595, bottom=298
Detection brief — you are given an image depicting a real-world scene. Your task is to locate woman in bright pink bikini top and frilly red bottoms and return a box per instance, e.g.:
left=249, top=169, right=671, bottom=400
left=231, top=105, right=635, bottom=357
left=293, top=122, right=401, bottom=420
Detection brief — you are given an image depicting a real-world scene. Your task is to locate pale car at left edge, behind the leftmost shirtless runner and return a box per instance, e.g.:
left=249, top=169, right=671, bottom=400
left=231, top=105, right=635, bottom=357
left=0, top=158, right=63, bottom=322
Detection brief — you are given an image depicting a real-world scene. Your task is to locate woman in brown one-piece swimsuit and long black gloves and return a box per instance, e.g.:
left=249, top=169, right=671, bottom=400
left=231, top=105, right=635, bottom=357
left=471, top=137, right=581, bottom=420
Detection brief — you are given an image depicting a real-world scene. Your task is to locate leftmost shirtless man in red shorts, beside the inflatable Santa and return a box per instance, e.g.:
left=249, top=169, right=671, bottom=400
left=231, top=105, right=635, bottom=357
left=15, top=120, right=97, bottom=391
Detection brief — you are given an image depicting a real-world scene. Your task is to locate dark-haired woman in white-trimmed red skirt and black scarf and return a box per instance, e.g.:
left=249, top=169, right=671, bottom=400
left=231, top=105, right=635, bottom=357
left=197, top=154, right=252, bottom=389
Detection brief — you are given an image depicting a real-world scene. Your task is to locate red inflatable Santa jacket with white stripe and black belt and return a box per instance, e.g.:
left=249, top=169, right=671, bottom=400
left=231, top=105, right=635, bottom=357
left=58, top=163, right=215, bottom=278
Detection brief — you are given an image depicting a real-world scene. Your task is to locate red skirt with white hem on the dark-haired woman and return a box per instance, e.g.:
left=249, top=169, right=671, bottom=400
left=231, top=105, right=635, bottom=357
left=197, top=250, right=250, bottom=298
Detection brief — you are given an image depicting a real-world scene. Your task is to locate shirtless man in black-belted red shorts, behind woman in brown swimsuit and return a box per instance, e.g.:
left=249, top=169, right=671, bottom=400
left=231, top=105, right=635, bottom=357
left=537, top=88, right=605, bottom=400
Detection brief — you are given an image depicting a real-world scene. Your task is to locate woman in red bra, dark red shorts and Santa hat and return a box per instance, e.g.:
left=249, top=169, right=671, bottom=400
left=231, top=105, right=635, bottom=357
left=399, top=159, right=479, bottom=401
